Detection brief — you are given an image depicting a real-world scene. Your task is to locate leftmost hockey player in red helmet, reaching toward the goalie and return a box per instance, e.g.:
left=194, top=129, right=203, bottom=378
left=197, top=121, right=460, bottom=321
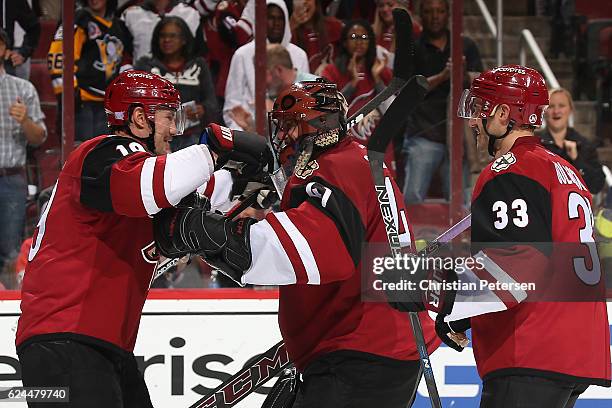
left=16, top=71, right=265, bottom=408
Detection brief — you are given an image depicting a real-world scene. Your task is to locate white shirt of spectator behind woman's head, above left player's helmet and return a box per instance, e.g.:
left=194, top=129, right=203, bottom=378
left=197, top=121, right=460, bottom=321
left=121, top=1, right=200, bottom=61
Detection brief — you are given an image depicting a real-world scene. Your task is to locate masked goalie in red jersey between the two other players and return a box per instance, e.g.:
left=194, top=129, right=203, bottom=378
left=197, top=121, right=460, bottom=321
left=154, top=80, right=439, bottom=408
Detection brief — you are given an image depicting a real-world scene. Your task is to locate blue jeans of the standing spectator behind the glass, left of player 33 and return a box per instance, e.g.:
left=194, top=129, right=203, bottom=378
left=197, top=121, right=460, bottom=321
left=402, top=136, right=470, bottom=204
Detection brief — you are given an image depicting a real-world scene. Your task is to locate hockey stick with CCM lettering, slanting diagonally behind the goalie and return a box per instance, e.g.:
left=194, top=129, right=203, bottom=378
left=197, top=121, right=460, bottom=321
left=184, top=215, right=471, bottom=408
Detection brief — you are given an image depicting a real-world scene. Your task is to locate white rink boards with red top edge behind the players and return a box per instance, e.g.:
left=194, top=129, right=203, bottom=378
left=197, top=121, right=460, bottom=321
left=0, top=289, right=612, bottom=408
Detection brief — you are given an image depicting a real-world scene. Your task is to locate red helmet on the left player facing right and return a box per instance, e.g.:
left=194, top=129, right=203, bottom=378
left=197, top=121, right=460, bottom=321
left=104, top=71, right=185, bottom=134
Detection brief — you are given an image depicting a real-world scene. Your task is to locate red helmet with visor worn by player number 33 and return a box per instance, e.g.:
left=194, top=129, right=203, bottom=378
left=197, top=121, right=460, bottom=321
left=457, top=65, right=548, bottom=126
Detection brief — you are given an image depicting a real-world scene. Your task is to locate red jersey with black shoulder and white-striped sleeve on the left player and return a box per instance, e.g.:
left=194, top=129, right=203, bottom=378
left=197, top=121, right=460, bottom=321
left=16, top=136, right=213, bottom=351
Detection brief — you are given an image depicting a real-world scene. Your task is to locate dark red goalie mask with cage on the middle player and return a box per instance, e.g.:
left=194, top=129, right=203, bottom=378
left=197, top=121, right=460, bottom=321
left=268, top=79, right=347, bottom=180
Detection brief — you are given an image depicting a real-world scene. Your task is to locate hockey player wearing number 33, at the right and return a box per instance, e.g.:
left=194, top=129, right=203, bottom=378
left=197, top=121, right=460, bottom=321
left=395, top=65, right=610, bottom=408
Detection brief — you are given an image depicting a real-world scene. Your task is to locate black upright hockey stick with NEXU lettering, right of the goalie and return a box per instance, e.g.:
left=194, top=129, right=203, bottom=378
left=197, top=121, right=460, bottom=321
left=368, top=9, right=442, bottom=408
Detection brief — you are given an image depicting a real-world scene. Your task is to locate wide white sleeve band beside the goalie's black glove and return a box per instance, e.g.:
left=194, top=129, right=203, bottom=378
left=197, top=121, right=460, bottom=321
left=242, top=220, right=297, bottom=285
